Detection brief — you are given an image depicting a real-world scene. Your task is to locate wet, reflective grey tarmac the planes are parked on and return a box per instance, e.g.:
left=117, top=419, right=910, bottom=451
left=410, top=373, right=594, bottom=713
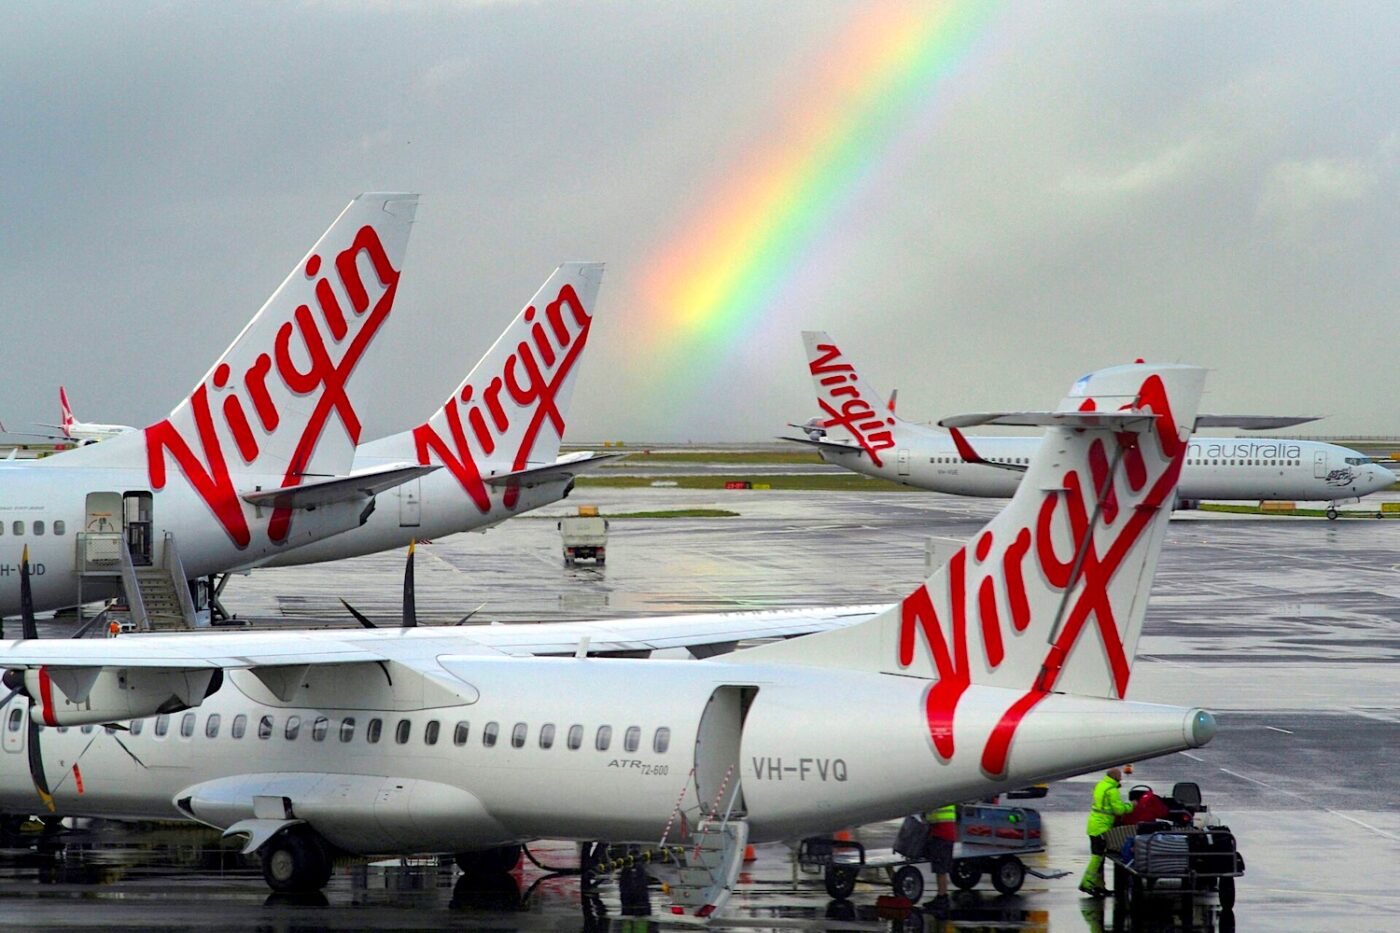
left=13, top=489, right=1400, bottom=933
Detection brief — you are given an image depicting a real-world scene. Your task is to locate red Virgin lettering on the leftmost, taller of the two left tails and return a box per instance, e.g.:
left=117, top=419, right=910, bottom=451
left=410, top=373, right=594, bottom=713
left=146, top=226, right=399, bottom=548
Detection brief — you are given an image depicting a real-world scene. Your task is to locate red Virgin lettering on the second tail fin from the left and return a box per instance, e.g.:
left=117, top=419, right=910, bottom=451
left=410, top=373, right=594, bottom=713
left=413, top=284, right=592, bottom=514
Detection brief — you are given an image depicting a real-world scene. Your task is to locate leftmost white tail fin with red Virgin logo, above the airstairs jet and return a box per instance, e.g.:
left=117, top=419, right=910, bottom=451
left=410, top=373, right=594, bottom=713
left=45, top=193, right=417, bottom=546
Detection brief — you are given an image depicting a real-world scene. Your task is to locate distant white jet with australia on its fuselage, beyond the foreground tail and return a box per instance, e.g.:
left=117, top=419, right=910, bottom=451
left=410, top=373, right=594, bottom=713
left=783, top=331, right=1396, bottom=518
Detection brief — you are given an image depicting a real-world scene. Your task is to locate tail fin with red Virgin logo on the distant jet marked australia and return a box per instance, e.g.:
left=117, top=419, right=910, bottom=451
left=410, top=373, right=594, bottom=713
left=802, top=331, right=904, bottom=467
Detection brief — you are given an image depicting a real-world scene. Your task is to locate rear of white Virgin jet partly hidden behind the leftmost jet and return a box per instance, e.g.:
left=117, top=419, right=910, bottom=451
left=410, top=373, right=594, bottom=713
left=267, top=262, right=616, bottom=566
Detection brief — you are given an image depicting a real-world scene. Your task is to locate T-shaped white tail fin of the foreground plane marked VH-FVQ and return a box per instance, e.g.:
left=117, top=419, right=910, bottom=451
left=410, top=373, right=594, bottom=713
left=735, top=364, right=1204, bottom=773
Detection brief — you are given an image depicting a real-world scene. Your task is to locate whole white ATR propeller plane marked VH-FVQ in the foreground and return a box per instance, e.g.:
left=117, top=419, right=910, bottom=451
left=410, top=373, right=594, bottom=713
left=0, top=366, right=1215, bottom=915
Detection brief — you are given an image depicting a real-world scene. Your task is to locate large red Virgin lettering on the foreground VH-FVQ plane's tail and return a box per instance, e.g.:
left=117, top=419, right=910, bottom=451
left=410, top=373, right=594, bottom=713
left=897, top=375, right=1186, bottom=778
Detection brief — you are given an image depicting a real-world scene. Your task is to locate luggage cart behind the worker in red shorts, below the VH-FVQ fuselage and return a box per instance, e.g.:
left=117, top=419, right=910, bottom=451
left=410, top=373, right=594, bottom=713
left=798, top=804, right=1068, bottom=901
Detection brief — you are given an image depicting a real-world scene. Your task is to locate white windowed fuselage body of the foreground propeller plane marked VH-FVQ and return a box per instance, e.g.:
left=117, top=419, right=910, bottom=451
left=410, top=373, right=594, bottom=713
left=0, top=647, right=1208, bottom=855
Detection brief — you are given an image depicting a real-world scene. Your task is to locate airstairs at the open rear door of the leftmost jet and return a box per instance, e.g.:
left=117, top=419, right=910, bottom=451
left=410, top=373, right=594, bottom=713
left=77, top=531, right=196, bottom=632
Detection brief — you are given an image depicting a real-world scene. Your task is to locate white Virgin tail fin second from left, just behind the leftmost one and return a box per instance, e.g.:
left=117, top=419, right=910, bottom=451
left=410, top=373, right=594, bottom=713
left=405, top=262, right=603, bottom=511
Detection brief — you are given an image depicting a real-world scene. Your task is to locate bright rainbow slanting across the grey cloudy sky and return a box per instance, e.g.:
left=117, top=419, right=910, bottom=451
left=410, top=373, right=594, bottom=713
left=640, top=0, right=997, bottom=359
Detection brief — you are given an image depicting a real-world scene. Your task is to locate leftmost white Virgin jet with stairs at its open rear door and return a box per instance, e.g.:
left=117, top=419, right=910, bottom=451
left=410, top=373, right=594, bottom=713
left=0, top=195, right=435, bottom=615
